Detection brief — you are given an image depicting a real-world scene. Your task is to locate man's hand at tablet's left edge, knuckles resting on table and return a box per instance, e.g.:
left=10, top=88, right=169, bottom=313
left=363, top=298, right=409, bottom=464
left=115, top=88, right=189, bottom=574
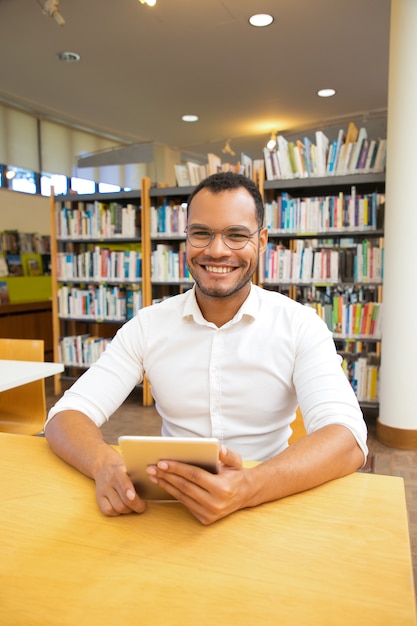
left=94, top=451, right=146, bottom=517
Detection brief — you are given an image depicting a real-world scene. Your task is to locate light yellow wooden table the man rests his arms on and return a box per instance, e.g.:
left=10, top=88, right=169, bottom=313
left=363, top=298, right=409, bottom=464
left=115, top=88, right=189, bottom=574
left=0, top=434, right=416, bottom=626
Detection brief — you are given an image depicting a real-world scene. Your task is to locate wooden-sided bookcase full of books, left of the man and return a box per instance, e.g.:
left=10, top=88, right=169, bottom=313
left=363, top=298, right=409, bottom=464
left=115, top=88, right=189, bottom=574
left=51, top=185, right=147, bottom=395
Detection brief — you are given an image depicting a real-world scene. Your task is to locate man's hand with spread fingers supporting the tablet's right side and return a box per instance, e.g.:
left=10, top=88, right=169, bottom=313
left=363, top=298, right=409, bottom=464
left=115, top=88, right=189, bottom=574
left=147, top=447, right=250, bottom=524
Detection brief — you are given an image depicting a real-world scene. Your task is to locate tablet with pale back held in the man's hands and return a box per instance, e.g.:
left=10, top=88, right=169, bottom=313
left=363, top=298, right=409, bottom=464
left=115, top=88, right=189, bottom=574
left=118, top=435, right=220, bottom=501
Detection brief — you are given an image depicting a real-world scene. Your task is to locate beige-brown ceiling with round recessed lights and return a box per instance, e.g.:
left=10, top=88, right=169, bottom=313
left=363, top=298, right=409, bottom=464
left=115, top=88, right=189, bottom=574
left=0, top=0, right=390, bottom=160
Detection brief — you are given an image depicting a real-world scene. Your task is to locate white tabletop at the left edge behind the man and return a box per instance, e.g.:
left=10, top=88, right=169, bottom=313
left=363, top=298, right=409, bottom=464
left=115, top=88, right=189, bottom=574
left=0, top=359, right=64, bottom=391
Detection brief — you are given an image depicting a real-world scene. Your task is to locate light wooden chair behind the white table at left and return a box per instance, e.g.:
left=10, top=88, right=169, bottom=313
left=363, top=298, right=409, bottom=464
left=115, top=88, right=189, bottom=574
left=0, top=339, right=46, bottom=435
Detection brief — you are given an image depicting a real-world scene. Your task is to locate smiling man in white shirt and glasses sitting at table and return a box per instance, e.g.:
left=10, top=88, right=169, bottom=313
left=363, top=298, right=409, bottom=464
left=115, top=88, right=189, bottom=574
left=45, top=173, right=367, bottom=524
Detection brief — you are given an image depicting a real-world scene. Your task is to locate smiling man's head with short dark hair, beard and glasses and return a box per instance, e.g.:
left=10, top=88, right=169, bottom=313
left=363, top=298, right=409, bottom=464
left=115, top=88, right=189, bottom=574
left=186, top=172, right=268, bottom=306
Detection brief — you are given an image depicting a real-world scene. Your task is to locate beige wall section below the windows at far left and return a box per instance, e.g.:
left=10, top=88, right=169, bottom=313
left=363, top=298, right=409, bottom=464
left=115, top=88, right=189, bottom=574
left=0, top=189, right=51, bottom=235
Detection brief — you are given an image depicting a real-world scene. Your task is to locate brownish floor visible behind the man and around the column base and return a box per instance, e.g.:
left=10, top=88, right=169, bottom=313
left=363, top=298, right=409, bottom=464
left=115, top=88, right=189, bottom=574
left=46, top=379, right=417, bottom=597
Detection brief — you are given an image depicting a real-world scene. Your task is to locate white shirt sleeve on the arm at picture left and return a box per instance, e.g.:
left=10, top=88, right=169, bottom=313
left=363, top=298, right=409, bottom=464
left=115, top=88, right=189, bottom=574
left=46, top=316, right=143, bottom=427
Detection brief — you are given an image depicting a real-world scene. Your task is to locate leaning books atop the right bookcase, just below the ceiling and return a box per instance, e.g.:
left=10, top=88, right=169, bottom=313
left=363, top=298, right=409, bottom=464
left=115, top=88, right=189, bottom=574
left=264, top=122, right=387, bottom=180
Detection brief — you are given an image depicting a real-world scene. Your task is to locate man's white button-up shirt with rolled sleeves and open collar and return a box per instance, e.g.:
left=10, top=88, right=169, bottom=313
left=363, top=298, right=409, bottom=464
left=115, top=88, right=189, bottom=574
left=48, top=285, right=367, bottom=461
